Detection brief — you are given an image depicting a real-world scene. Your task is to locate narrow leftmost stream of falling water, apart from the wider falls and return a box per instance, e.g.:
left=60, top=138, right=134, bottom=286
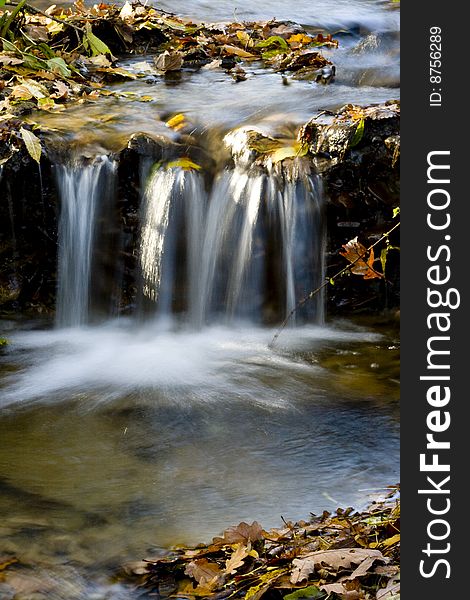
left=56, top=156, right=116, bottom=327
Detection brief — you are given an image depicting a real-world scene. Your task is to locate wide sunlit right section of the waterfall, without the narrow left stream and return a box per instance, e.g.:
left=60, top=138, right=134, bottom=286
left=140, top=161, right=323, bottom=327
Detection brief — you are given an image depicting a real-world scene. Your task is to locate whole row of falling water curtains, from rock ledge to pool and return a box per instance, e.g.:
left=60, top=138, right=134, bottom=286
left=53, top=154, right=324, bottom=328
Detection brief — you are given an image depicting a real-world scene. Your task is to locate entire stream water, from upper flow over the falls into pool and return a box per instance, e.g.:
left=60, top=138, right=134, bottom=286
left=0, top=0, right=399, bottom=600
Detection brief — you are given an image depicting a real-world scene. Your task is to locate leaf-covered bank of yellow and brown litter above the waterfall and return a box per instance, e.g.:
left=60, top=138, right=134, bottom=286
left=0, top=0, right=337, bottom=119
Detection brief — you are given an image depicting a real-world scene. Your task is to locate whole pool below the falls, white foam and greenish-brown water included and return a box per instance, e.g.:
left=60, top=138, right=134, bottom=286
left=0, top=322, right=398, bottom=598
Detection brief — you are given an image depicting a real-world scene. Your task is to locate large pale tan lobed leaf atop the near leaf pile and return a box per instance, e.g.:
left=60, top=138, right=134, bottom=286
left=290, top=548, right=388, bottom=584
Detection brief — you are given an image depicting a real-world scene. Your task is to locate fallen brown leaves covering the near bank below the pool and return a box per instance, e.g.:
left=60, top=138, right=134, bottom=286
left=124, top=486, right=400, bottom=600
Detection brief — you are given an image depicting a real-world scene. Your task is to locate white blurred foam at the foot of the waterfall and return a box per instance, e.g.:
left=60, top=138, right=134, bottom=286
left=1, top=321, right=378, bottom=408
